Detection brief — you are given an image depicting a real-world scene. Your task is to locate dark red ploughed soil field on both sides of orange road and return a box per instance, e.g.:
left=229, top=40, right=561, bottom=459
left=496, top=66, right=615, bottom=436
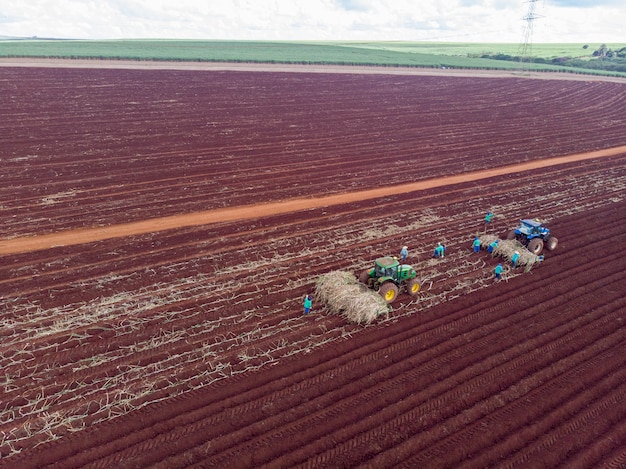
left=0, top=63, right=626, bottom=468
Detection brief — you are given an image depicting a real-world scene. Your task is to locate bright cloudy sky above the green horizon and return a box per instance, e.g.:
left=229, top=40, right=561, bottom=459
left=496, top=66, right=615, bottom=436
left=0, top=0, right=626, bottom=44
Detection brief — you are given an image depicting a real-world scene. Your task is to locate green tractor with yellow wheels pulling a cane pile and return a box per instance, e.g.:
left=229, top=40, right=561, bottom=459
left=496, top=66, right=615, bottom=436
left=359, top=257, right=420, bottom=303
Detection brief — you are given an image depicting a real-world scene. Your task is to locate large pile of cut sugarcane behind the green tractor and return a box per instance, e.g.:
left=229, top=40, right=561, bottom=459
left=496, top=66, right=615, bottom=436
left=315, top=270, right=389, bottom=324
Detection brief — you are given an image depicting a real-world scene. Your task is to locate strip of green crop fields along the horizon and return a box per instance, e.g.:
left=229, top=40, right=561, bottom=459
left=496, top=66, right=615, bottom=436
left=0, top=39, right=626, bottom=76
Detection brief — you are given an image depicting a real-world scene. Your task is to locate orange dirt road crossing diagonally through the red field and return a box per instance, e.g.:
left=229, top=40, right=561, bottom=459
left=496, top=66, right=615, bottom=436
left=0, top=145, right=626, bottom=255
